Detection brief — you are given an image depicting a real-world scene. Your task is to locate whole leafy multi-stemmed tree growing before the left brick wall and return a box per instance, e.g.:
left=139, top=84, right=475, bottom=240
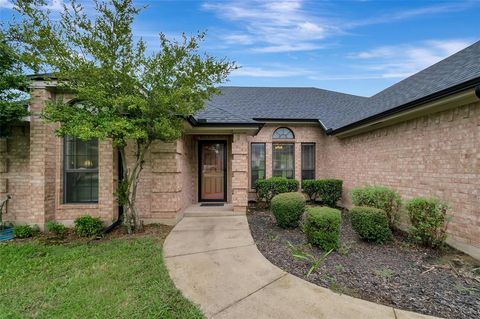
left=10, top=0, right=235, bottom=232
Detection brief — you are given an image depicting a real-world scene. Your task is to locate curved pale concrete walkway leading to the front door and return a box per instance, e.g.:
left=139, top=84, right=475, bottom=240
left=164, top=216, right=433, bottom=319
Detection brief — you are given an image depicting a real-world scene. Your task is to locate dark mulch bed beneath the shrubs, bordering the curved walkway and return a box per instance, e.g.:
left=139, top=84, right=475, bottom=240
left=247, top=209, right=480, bottom=318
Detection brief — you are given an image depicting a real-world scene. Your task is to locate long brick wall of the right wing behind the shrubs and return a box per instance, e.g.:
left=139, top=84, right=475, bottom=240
left=321, top=102, right=480, bottom=248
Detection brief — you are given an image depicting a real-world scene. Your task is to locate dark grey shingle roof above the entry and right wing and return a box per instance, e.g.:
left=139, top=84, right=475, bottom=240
left=195, top=41, right=480, bottom=130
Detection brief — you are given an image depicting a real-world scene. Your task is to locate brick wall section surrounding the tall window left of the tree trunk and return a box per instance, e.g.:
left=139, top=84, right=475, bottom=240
left=4, top=85, right=118, bottom=228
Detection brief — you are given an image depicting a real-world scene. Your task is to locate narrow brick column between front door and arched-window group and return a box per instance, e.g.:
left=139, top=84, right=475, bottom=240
left=232, top=134, right=248, bottom=213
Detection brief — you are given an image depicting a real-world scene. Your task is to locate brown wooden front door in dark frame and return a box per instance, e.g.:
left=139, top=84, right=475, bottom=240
left=198, top=141, right=227, bottom=202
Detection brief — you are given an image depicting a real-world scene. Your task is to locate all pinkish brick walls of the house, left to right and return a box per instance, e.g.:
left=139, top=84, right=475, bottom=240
left=5, top=83, right=480, bottom=258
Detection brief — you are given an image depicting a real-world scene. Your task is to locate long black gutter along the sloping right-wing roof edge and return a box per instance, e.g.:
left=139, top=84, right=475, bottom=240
left=327, top=77, right=480, bottom=135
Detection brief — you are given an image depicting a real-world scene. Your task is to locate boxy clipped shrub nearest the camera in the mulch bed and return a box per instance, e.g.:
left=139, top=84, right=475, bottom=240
left=304, top=207, right=342, bottom=251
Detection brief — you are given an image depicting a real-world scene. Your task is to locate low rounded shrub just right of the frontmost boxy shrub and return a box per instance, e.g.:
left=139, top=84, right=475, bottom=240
left=350, top=206, right=392, bottom=244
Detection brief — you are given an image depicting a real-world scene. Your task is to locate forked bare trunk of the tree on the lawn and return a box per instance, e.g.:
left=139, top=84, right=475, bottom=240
left=117, top=141, right=151, bottom=234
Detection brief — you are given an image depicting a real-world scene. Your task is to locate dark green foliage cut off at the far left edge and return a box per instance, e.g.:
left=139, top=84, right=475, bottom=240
left=0, top=32, right=28, bottom=138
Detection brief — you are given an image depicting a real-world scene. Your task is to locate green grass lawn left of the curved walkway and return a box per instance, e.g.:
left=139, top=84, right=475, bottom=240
left=0, top=237, right=203, bottom=318
